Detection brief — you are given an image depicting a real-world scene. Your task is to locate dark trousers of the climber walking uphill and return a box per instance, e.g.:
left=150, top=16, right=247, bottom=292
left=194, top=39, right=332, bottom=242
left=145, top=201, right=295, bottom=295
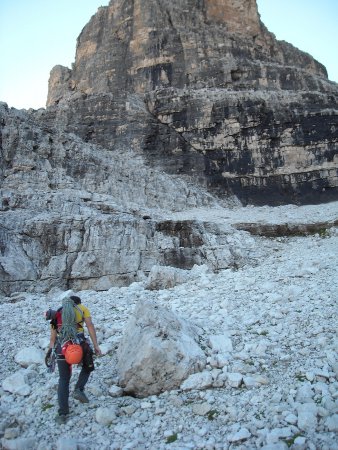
left=57, top=355, right=90, bottom=414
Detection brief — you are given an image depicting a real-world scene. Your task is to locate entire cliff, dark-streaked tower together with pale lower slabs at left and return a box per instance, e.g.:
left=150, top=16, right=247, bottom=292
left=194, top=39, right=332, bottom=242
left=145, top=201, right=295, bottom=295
left=0, top=0, right=338, bottom=295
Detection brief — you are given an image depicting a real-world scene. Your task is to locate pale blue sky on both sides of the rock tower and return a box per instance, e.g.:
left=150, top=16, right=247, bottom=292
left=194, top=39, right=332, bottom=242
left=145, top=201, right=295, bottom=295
left=0, top=0, right=338, bottom=109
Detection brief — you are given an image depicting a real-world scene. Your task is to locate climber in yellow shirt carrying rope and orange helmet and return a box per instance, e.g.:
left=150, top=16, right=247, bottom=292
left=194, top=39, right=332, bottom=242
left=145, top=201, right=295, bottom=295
left=45, top=295, right=101, bottom=424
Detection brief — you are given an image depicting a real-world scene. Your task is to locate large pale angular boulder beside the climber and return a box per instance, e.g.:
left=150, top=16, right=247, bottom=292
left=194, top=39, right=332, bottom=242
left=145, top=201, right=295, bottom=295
left=117, top=301, right=206, bottom=398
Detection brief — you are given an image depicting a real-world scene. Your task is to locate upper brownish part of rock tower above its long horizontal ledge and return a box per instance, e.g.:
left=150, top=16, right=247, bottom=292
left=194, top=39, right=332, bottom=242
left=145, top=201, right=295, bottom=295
left=47, top=0, right=326, bottom=106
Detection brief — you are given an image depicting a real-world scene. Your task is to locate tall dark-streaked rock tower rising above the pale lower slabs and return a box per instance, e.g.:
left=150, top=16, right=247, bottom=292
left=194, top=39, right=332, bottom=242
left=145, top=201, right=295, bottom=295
left=47, top=0, right=338, bottom=204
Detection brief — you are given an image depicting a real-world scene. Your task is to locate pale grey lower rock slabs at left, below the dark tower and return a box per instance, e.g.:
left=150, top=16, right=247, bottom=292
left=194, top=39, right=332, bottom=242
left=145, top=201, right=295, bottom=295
left=0, top=102, right=250, bottom=295
